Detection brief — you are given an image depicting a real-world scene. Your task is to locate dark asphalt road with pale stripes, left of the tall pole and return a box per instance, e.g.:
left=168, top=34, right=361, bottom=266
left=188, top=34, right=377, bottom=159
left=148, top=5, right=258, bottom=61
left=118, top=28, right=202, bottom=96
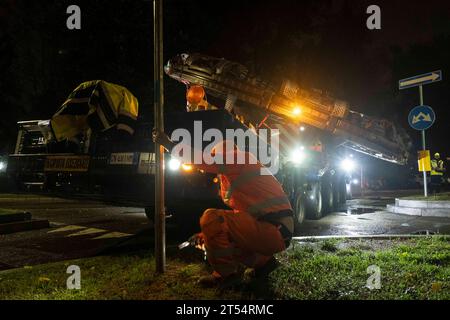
left=0, top=195, right=151, bottom=269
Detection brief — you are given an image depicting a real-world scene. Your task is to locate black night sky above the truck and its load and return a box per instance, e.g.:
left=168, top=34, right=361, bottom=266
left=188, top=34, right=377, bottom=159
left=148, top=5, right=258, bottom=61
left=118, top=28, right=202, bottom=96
left=0, top=0, right=450, bottom=170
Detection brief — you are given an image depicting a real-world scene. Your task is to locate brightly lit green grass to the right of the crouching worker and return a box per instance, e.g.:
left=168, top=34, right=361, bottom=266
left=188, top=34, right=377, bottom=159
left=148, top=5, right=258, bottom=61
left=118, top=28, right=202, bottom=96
left=270, top=237, right=450, bottom=300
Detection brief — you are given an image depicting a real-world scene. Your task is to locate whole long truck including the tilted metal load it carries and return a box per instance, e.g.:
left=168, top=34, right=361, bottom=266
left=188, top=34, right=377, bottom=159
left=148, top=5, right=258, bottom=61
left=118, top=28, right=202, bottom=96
left=7, top=54, right=410, bottom=231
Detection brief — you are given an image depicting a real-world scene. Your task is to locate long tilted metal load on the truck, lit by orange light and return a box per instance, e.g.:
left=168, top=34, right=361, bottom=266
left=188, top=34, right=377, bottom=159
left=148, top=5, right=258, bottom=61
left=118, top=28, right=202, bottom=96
left=165, top=54, right=410, bottom=164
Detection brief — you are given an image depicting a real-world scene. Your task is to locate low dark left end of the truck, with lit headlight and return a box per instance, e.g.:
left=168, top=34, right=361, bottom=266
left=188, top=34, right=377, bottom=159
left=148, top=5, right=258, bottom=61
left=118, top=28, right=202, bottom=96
left=6, top=110, right=256, bottom=219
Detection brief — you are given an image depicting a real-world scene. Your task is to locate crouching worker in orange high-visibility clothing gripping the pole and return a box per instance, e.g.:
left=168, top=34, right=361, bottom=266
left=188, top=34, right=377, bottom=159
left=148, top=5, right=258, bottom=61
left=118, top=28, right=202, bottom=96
left=154, top=132, right=294, bottom=286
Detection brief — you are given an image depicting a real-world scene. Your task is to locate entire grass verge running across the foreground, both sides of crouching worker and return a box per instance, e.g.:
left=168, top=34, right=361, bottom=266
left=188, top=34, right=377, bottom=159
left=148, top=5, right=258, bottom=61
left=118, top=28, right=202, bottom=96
left=0, top=237, right=450, bottom=299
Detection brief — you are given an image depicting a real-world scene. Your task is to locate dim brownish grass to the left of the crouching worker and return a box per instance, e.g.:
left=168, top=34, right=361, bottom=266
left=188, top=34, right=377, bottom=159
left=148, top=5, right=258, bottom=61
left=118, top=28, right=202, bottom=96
left=0, top=253, right=244, bottom=300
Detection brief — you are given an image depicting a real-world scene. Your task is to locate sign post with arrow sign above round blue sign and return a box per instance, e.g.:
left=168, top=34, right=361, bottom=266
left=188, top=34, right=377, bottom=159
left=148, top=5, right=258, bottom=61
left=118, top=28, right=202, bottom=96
left=398, top=70, right=442, bottom=197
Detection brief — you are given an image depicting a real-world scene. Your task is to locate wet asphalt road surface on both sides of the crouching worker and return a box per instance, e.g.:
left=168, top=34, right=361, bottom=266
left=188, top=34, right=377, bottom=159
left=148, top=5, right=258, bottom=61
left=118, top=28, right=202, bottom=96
left=0, top=193, right=450, bottom=270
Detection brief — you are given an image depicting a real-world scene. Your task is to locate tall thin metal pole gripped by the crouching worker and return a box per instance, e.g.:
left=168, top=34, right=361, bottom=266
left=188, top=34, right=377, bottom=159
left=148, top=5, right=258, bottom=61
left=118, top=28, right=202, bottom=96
left=153, top=0, right=166, bottom=273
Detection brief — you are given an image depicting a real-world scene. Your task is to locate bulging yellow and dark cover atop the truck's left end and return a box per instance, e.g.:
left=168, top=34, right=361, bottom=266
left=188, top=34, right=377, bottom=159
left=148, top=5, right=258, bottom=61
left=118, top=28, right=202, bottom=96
left=50, top=80, right=139, bottom=141
